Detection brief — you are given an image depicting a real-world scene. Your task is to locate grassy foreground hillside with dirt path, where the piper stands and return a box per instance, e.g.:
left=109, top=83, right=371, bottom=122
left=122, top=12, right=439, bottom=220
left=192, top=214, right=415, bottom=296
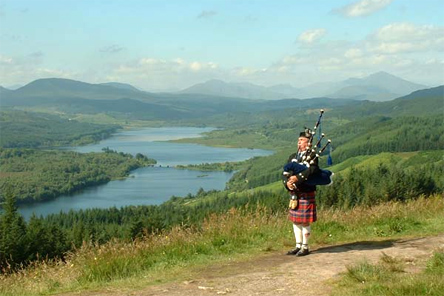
left=0, top=196, right=444, bottom=296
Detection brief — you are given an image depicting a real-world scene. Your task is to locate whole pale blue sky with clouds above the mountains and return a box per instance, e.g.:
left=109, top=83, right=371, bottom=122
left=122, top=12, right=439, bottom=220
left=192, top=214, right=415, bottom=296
left=0, top=0, right=444, bottom=91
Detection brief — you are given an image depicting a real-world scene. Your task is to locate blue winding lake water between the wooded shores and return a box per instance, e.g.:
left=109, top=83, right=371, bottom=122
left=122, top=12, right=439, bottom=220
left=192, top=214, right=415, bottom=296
left=19, top=127, right=273, bottom=219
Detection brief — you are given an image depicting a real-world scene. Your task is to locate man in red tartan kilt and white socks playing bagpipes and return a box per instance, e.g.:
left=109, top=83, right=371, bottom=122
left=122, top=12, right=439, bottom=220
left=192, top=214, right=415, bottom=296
left=283, top=110, right=333, bottom=256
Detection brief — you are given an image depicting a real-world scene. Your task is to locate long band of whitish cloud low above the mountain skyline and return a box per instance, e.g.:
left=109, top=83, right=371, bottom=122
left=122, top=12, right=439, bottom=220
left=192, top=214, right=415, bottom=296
left=4, top=18, right=444, bottom=91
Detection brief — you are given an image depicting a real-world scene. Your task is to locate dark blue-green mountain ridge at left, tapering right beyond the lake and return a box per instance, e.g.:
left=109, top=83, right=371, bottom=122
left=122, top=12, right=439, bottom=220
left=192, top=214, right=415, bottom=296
left=0, top=78, right=358, bottom=120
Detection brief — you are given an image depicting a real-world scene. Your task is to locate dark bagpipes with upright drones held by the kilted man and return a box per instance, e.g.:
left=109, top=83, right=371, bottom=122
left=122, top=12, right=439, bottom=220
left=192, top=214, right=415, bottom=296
left=283, top=109, right=333, bottom=191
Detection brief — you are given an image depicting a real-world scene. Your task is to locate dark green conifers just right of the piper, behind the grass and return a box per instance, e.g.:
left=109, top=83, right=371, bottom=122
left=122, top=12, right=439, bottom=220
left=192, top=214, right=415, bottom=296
left=317, top=162, right=444, bottom=209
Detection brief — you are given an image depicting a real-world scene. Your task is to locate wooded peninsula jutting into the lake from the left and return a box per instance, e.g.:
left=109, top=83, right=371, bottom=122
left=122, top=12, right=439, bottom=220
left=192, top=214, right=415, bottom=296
left=0, top=148, right=156, bottom=203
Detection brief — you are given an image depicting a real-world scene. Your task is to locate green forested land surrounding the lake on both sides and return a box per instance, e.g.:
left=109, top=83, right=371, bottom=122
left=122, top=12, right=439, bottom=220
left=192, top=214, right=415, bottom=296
left=0, top=88, right=444, bottom=271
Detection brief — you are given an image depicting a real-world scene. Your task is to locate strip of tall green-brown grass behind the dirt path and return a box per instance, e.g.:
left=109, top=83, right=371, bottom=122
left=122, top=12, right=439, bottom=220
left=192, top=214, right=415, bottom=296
left=0, top=195, right=444, bottom=295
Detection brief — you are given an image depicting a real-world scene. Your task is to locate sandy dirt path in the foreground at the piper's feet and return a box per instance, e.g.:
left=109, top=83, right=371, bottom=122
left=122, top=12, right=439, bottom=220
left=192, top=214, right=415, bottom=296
left=64, top=234, right=444, bottom=296
